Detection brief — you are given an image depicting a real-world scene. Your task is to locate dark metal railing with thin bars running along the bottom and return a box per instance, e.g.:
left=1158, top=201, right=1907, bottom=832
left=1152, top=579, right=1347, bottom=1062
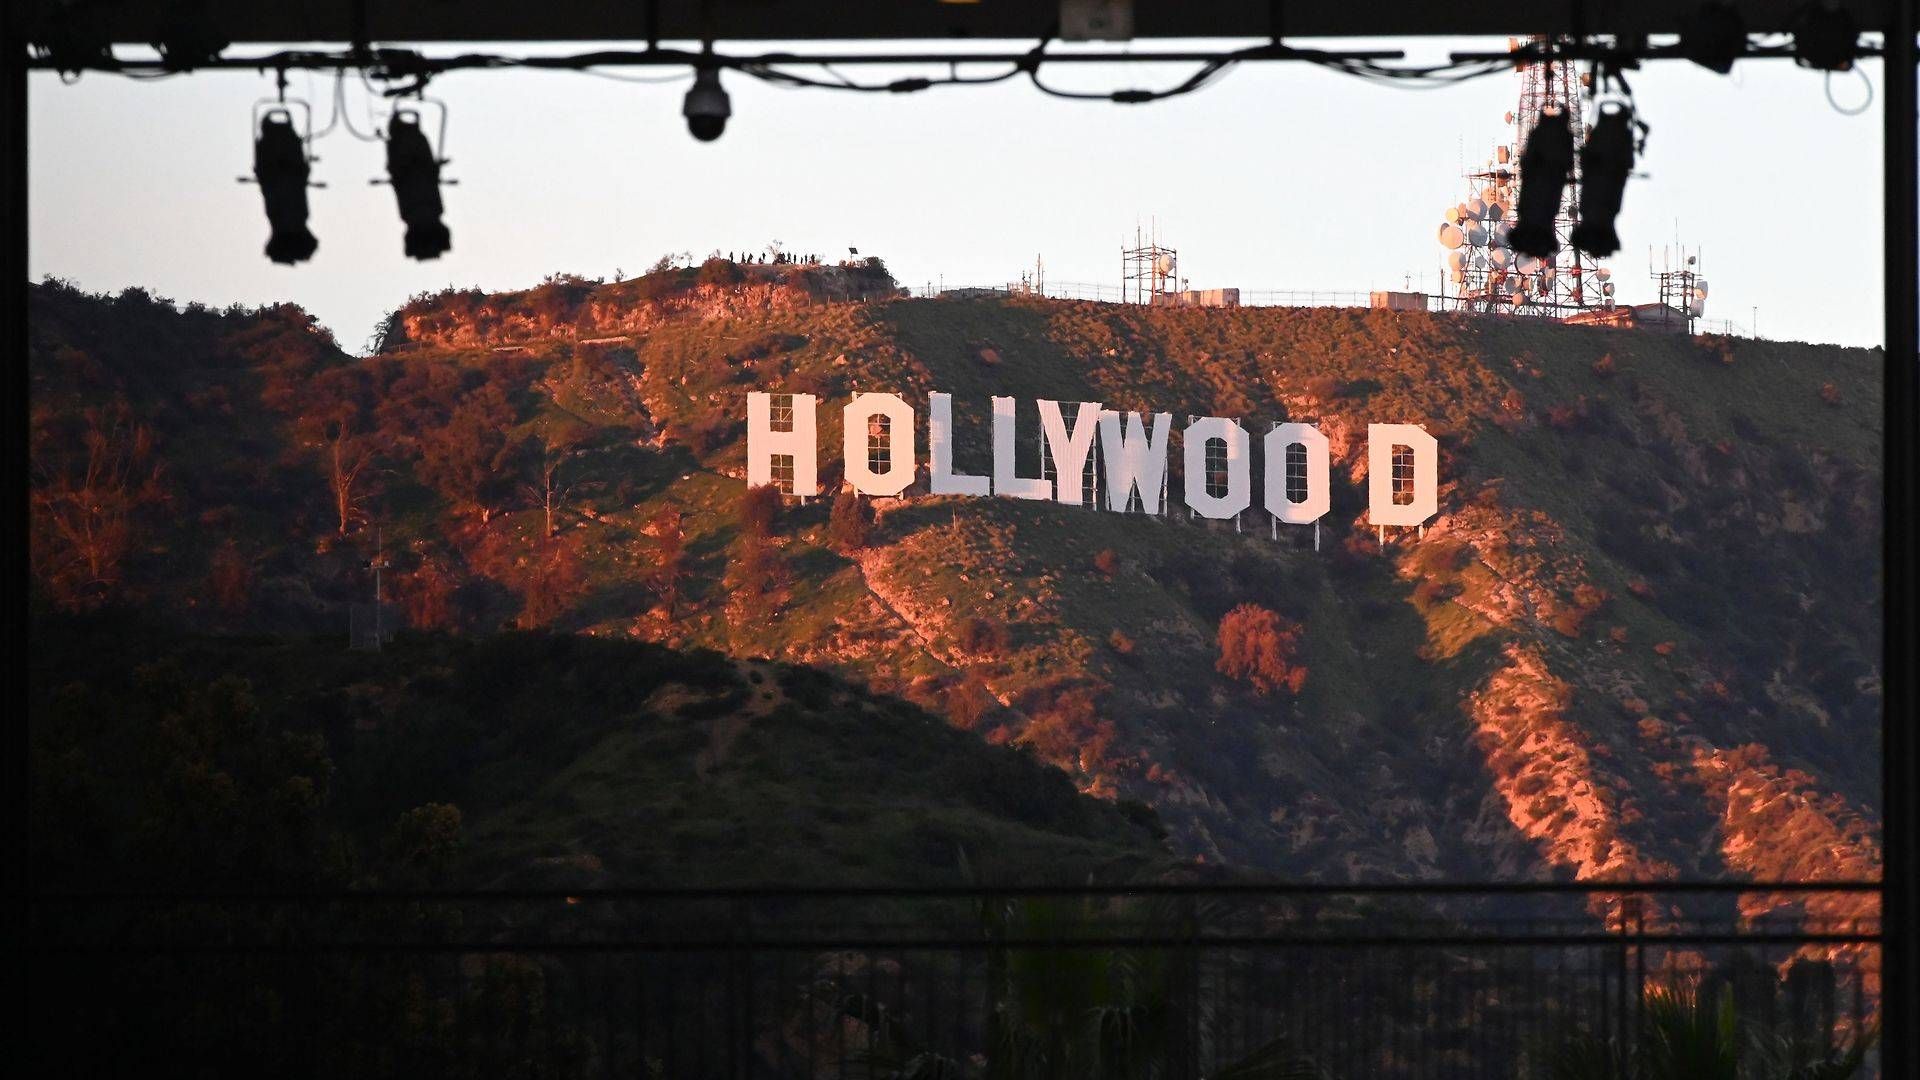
left=27, top=882, right=1880, bottom=1080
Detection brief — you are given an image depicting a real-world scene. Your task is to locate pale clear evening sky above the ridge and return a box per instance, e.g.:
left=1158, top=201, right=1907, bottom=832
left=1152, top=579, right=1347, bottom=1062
left=29, top=38, right=1884, bottom=350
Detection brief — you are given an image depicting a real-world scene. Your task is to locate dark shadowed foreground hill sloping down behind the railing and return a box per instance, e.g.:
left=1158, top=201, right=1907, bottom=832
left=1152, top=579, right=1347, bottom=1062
left=29, top=613, right=1167, bottom=892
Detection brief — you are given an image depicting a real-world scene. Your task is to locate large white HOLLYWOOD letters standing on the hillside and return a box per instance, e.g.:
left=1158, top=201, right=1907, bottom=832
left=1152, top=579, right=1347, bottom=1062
left=747, top=394, right=1440, bottom=527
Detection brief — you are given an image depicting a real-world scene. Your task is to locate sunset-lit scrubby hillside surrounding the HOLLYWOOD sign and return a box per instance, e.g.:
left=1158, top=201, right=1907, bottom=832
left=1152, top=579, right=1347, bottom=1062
left=31, top=267, right=1882, bottom=915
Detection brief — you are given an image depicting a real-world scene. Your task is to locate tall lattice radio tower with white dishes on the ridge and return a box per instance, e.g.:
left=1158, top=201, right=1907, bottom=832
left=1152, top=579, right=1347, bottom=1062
left=1440, top=38, right=1613, bottom=317
